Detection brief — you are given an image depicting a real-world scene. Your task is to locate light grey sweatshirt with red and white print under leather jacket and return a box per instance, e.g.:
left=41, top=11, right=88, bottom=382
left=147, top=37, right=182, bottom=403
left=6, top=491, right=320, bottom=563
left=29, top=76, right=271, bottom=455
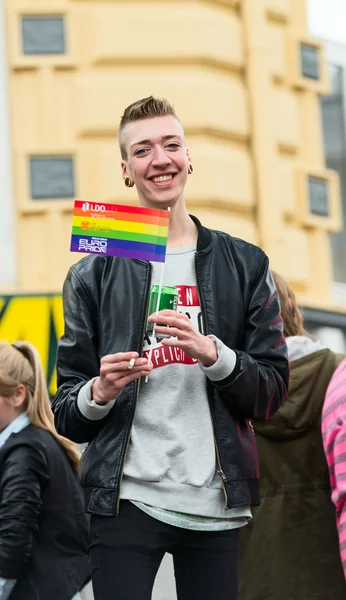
left=78, top=246, right=251, bottom=519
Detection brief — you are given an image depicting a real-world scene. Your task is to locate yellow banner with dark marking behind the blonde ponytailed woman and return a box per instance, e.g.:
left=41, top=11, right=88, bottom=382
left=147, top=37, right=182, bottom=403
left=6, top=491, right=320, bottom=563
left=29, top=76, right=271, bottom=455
left=0, top=295, right=64, bottom=396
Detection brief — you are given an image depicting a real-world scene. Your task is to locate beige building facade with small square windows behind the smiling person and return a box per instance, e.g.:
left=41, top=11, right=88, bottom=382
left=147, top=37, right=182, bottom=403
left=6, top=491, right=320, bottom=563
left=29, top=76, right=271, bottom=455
left=0, top=0, right=346, bottom=364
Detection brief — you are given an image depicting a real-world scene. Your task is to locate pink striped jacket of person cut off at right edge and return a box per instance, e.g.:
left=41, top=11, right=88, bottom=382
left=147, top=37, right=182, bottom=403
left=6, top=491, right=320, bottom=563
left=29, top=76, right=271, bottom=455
left=322, top=359, right=346, bottom=578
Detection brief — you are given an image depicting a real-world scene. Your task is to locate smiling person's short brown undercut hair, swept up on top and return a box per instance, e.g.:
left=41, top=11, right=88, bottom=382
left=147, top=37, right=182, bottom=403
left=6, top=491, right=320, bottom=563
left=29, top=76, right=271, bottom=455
left=119, top=96, right=180, bottom=160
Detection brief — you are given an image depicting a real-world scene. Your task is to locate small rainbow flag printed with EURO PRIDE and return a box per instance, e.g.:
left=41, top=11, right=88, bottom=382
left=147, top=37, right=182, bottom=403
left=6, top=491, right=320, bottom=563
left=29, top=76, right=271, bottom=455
left=70, top=200, right=169, bottom=262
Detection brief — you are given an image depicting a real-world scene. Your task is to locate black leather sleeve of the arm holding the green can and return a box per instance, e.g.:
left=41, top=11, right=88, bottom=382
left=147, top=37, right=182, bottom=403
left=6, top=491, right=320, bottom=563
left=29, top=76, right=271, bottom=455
left=212, top=255, right=289, bottom=420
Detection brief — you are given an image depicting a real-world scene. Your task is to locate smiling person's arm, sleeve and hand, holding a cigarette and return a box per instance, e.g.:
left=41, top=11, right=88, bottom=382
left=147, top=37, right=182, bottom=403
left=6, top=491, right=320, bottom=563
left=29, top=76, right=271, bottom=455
left=52, top=267, right=151, bottom=443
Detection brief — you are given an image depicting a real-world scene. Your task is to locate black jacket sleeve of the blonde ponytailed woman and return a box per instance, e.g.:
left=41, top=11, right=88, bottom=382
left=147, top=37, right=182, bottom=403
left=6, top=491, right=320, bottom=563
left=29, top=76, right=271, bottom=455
left=0, top=445, right=49, bottom=580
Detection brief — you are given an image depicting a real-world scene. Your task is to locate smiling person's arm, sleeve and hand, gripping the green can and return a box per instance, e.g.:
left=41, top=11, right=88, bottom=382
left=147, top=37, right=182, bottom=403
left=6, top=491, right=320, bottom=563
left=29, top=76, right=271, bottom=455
left=153, top=255, right=289, bottom=420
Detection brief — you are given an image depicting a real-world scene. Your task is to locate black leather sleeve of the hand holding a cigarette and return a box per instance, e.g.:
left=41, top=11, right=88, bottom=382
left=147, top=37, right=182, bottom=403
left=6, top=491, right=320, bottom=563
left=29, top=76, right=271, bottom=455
left=52, top=267, right=108, bottom=444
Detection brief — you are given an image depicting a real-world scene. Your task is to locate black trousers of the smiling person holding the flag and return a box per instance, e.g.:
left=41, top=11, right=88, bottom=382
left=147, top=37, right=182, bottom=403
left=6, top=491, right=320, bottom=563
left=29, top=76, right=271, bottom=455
left=90, top=500, right=239, bottom=600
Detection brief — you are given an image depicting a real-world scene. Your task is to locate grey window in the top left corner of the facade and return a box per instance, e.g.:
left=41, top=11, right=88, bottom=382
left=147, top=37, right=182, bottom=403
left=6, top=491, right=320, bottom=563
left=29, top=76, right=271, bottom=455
left=22, top=15, right=66, bottom=55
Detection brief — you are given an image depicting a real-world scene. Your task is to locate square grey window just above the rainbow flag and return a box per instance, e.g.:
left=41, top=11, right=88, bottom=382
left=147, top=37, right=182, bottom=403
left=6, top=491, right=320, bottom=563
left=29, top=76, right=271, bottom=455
left=30, top=156, right=75, bottom=200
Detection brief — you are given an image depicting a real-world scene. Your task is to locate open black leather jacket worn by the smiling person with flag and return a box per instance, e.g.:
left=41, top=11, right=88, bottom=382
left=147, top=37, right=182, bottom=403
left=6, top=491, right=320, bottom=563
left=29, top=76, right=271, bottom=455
left=53, top=217, right=289, bottom=515
